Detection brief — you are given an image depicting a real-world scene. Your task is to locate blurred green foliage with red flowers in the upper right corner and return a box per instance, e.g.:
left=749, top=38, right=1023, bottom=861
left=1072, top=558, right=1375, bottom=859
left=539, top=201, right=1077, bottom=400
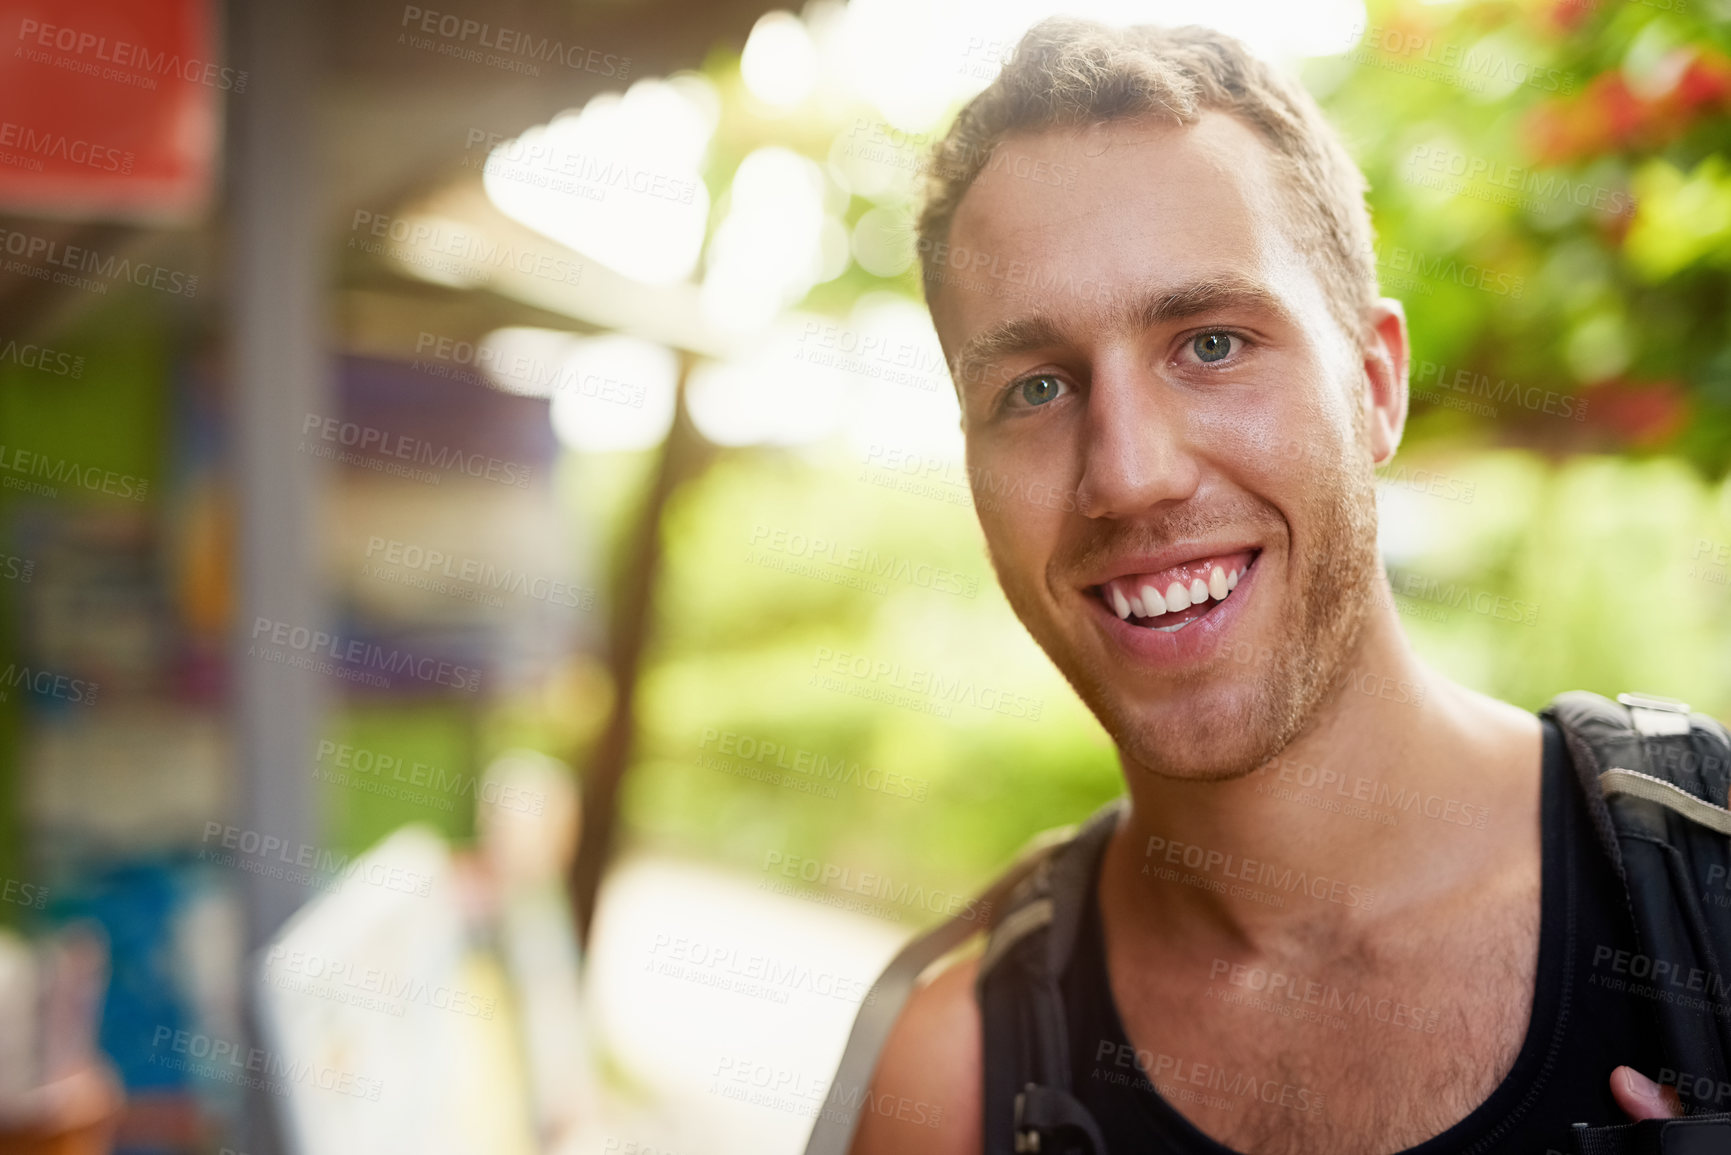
left=1305, top=0, right=1731, bottom=464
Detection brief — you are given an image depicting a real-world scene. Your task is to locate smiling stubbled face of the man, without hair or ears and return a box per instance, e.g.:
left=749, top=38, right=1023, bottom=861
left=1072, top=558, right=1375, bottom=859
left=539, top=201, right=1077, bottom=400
left=933, top=114, right=1399, bottom=779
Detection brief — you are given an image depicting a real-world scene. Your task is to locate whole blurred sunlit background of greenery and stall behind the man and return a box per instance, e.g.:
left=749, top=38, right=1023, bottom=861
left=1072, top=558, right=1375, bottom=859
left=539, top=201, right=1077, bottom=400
left=0, top=0, right=1731, bottom=1155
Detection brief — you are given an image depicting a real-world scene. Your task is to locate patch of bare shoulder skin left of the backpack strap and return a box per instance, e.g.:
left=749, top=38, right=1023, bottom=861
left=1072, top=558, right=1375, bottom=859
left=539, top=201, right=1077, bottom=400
left=852, top=959, right=981, bottom=1155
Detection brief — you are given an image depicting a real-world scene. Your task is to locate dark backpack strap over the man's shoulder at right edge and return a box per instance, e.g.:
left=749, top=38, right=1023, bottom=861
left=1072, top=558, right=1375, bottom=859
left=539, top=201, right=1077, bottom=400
left=1541, top=691, right=1731, bottom=1152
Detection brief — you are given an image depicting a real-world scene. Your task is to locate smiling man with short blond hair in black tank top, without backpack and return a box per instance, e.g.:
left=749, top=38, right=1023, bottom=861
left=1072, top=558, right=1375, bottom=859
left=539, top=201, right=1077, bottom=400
left=830, top=21, right=1707, bottom=1155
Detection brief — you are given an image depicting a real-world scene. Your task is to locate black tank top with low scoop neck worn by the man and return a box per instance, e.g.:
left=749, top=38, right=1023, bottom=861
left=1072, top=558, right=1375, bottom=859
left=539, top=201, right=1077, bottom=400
left=1063, top=720, right=1662, bottom=1155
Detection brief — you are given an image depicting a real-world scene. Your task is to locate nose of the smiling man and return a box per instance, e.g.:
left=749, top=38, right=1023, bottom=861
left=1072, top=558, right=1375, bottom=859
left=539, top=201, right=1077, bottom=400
left=1077, top=364, right=1201, bottom=518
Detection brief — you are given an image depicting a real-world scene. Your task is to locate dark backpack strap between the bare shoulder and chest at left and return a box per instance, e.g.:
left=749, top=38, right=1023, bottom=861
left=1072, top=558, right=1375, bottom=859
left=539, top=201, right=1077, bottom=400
left=975, top=798, right=1123, bottom=1155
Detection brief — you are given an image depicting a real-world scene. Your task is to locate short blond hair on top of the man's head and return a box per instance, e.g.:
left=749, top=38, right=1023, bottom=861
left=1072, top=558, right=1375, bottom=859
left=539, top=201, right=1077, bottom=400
left=917, top=17, right=1378, bottom=338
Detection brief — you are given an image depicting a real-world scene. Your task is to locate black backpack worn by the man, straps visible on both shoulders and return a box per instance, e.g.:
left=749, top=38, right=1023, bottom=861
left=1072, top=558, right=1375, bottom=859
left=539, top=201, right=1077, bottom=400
left=805, top=691, right=1731, bottom=1155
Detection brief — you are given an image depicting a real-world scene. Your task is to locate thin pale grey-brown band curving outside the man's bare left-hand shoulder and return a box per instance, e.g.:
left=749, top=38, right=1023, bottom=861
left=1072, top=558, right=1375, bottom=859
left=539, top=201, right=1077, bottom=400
left=805, top=813, right=1107, bottom=1155
